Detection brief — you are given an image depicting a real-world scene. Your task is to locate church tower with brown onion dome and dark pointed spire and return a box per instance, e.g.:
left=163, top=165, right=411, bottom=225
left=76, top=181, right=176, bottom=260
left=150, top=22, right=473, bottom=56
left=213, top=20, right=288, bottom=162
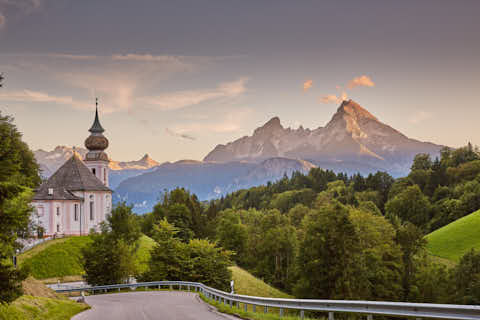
left=84, top=99, right=110, bottom=187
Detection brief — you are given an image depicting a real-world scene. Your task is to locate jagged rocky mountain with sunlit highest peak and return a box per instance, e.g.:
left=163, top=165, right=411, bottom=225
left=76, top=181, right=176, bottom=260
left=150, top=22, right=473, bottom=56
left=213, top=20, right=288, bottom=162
left=204, top=100, right=442, bottom=176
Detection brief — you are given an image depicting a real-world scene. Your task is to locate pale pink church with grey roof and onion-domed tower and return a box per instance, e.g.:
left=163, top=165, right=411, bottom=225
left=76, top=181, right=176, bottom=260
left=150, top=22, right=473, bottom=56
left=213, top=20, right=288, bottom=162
left=32, top=102, right=112, bottom=237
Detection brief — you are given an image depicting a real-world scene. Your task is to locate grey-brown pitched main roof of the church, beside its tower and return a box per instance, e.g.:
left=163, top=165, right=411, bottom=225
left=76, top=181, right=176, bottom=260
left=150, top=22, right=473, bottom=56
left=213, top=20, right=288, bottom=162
left=33, top=152, right=112, bottom=200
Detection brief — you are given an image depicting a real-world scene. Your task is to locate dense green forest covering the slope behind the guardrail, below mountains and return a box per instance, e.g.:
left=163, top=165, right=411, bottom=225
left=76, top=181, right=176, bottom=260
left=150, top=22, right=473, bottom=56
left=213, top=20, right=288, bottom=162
left=139, top=144, right=480, bottom=303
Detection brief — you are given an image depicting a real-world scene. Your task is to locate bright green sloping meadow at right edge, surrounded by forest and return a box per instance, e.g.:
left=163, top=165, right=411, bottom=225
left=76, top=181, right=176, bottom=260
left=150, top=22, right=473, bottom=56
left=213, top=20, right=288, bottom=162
left=426, top=210, right=480, bottom=262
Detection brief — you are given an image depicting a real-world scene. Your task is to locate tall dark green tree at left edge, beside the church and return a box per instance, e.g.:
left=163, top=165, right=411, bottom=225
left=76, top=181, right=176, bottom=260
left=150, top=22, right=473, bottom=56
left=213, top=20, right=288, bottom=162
left=0, top=74, right=40, bottom=303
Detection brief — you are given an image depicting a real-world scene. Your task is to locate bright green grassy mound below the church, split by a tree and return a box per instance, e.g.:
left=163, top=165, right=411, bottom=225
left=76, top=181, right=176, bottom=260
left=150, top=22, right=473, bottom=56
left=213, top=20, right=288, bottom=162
left=18, top=235, right=155, bottom=279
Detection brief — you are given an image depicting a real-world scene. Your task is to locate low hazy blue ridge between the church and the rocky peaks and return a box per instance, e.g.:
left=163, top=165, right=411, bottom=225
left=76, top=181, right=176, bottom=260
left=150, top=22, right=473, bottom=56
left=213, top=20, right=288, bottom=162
left=113, top=158, right=315, bottom=213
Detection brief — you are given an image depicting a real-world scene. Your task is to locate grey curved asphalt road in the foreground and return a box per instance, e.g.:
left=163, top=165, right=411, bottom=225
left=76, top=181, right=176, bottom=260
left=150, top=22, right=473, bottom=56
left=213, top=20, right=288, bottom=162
left=72, top=291, right=238, bottom=320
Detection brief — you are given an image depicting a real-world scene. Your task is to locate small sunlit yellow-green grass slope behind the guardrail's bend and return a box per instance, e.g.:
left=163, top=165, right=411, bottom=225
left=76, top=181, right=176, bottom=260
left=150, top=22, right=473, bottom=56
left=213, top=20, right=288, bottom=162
left=230, top=267, right=293, bottom=298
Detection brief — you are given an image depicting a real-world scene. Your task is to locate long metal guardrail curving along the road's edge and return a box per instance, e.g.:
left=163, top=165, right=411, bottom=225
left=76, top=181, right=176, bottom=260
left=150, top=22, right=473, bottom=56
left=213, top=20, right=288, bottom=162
left=55, top=281, right=480, bottom=320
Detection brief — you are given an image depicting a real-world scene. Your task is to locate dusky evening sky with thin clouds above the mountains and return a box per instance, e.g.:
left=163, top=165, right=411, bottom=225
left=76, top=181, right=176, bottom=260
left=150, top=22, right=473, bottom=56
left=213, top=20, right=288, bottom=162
left=0, top=0, right=480, bottom=162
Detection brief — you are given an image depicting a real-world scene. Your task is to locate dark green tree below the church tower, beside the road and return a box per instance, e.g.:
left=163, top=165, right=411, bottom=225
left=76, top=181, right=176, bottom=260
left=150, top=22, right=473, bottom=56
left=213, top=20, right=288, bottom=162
left=82, top=203, right=141, bottom=285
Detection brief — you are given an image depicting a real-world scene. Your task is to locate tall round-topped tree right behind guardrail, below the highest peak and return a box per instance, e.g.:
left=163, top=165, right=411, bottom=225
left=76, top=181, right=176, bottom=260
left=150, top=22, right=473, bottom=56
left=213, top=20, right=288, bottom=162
left=294, top=201, right=363, bottom=299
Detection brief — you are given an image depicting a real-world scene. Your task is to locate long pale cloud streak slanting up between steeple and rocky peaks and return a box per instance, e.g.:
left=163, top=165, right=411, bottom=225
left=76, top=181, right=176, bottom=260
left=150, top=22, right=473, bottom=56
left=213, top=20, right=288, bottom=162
left=141, top=78, right=247, bottom=110
